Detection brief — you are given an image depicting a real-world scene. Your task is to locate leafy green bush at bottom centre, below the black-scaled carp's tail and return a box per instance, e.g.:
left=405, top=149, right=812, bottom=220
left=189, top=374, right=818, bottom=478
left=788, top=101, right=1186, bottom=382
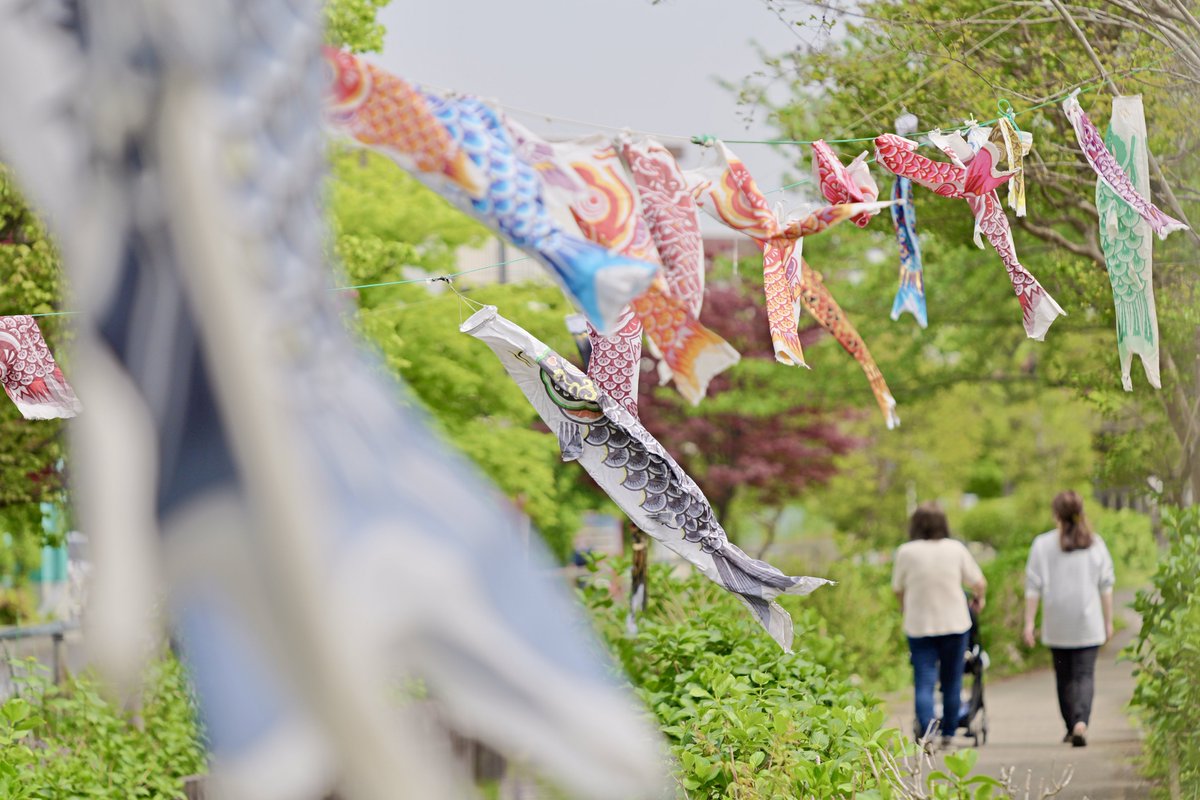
left=584, top=567, right=926, bottom=800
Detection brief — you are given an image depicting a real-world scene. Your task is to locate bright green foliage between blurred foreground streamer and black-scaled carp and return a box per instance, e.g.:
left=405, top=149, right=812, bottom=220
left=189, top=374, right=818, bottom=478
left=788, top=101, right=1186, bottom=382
left=329, top=142, right=608, bottom=559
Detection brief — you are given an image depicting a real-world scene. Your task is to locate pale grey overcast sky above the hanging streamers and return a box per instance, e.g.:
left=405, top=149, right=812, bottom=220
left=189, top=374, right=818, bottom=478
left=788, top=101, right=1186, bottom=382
left=372, top=0, right=818, bottom=190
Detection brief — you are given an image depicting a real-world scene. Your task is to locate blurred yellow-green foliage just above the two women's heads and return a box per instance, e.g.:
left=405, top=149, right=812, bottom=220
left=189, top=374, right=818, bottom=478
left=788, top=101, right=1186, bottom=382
left=805, top=383, right=1094, bottom=548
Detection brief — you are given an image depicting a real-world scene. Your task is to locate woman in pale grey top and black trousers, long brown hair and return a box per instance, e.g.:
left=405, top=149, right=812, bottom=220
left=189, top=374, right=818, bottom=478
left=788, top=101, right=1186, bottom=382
left=1025, top=492, right=1114, bottom=747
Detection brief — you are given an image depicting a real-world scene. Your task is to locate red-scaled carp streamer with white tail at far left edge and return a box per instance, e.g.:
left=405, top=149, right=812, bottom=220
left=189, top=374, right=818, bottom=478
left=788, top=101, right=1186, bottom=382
left=0, top=314, right=82, bottom=420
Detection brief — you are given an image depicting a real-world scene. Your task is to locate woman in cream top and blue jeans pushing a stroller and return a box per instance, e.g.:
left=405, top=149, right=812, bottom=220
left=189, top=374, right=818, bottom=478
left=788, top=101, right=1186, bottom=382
left=892, top=504, right=988, bottom=744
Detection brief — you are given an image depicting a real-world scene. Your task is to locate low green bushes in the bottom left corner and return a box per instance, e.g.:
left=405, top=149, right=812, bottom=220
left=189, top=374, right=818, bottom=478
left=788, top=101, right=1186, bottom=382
left=0, top=657, right=204, bottom=800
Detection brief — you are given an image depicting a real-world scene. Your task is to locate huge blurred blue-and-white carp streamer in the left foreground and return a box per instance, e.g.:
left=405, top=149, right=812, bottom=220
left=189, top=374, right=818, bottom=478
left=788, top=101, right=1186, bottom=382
left=0, top=0, right=665, bottom=800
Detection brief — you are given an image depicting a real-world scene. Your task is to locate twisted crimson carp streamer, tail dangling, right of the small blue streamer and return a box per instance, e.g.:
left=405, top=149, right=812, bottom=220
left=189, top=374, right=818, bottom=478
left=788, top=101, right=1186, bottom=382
left=875, top=133, right=1067, bottom=342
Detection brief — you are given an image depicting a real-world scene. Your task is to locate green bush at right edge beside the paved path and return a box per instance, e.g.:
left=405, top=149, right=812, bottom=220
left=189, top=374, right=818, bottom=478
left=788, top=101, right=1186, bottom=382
left=1127, top=506, right=1200, bottom=798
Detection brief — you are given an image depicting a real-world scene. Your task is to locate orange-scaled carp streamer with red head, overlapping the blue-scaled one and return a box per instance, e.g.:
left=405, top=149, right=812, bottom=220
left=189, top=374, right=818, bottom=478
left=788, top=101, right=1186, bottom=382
left=322, top=46, right=487, bottom=197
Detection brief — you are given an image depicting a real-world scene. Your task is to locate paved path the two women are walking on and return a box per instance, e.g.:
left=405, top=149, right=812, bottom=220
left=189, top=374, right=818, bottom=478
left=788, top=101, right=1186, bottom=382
left=892, top=593, right=1150, bottom=800
